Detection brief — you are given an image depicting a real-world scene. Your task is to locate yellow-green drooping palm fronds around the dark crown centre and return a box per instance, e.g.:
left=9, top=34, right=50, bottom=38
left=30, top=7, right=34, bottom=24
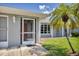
left=50, top=4, right=79, bottom=29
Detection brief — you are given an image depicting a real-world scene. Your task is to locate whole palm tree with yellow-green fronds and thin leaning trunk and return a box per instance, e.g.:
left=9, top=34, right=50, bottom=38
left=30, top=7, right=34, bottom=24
left=50, top=4, right=79, bottom=53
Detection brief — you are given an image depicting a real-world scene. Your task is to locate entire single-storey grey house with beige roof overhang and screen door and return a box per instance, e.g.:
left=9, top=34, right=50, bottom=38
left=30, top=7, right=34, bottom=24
left=0, top=6, right=70, bottom=48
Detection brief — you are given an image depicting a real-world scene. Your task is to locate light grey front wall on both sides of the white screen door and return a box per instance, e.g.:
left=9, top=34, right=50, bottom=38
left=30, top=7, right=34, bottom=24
left=1, top=14, right=45, bottom=47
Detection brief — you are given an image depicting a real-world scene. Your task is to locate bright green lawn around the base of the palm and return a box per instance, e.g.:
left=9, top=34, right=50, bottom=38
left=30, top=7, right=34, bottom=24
left=41, top=37, right=79, bottom=56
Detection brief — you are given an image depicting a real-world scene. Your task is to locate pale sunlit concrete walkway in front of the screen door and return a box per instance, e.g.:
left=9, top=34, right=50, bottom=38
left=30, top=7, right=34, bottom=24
left=0, top=45, right=47, bottom=56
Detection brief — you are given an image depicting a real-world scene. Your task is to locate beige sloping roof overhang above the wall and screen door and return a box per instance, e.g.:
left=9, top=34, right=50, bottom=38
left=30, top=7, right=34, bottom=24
left=0, top=6, right=48, bottom=18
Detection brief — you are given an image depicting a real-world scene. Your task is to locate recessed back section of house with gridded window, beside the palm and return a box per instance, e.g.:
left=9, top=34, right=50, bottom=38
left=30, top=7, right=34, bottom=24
left=39, top=17, right=65, bottom=38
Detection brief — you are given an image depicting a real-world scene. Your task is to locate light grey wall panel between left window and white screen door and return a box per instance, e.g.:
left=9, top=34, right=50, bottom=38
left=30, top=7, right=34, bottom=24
left=8, top=15, right=20, bottom=47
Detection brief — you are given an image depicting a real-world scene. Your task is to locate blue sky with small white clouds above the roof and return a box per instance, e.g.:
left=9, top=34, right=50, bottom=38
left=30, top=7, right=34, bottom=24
left=0, top=3, right=59, bottom=14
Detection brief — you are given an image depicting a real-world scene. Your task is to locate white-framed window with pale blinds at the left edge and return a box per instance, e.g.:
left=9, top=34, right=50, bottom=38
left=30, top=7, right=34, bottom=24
left=0, top=17, right=7, bottom=42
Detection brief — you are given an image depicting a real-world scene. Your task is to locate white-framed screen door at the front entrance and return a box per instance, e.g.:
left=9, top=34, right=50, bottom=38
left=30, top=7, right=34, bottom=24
left=21, top=18, right=35, bottom=45
